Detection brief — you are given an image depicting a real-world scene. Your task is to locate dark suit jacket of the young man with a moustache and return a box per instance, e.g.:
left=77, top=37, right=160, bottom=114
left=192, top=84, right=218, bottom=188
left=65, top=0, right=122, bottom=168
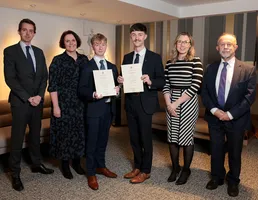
left=123, top=49, right=165, bottom=114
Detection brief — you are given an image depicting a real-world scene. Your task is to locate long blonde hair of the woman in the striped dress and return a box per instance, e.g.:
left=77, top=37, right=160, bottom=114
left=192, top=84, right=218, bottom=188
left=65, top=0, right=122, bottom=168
left=171, top=32, right=195, bottom=63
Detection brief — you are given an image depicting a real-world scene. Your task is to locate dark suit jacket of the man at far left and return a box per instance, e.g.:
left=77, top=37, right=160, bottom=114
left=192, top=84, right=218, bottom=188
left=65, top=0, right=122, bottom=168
left=4, top=43, right=48, bottom=106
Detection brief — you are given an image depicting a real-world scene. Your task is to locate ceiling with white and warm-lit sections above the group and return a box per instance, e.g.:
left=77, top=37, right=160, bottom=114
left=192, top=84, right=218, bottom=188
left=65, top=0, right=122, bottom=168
left=0, top=0, right=258, bottom=24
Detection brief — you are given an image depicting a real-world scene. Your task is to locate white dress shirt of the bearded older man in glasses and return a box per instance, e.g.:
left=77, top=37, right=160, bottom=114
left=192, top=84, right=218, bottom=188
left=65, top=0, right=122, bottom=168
left=211, top=57, right=236, bottom=120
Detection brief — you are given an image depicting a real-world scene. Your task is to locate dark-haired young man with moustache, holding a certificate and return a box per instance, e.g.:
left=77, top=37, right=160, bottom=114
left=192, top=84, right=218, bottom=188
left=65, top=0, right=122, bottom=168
left=118, top=23, right=165, bottom=183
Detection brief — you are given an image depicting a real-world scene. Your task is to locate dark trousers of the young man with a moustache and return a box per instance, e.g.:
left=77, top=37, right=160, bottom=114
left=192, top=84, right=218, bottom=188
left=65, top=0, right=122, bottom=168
left=126, top=95, right=153, bottom=174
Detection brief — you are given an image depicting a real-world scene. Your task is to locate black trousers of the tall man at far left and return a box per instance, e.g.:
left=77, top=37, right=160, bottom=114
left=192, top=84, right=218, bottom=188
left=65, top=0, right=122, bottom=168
left=9, top=102, right=43, bottom=176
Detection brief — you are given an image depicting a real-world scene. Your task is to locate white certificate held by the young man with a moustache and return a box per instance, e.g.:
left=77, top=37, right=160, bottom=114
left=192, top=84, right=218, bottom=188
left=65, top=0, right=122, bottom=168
left=121, top=64, right=143, bottom=93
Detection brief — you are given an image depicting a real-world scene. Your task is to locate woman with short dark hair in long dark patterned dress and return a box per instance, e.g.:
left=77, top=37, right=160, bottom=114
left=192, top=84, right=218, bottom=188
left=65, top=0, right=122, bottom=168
left=48, top=30, right=88, bottom=179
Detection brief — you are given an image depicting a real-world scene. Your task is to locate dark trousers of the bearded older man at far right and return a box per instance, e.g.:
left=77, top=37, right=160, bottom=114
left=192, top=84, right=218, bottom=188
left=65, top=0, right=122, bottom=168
left=209, top=121, right=244, bottom=184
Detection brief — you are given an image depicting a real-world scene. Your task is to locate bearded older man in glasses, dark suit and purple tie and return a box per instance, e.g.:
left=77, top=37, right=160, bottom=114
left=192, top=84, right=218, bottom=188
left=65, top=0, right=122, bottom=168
left=202, top=33, right=256, bottom=197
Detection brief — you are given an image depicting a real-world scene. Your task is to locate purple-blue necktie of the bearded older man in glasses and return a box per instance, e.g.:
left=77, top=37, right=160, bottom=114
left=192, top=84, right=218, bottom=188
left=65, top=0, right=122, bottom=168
left=218, top=62, right=228, bottom=107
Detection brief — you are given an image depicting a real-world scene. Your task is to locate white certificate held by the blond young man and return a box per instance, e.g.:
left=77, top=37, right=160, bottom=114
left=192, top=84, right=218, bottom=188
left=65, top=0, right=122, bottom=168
left=93, top=69, right=116, bottom=97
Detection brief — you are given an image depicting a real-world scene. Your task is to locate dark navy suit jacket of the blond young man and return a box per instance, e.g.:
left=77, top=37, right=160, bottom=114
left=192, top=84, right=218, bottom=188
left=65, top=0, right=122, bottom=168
left=78, top=59, right=118, bottom=117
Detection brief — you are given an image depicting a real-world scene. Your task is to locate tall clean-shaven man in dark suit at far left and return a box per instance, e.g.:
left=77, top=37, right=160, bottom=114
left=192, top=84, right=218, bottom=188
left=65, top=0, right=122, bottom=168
left=4, top=19, right=54, bottom=191
